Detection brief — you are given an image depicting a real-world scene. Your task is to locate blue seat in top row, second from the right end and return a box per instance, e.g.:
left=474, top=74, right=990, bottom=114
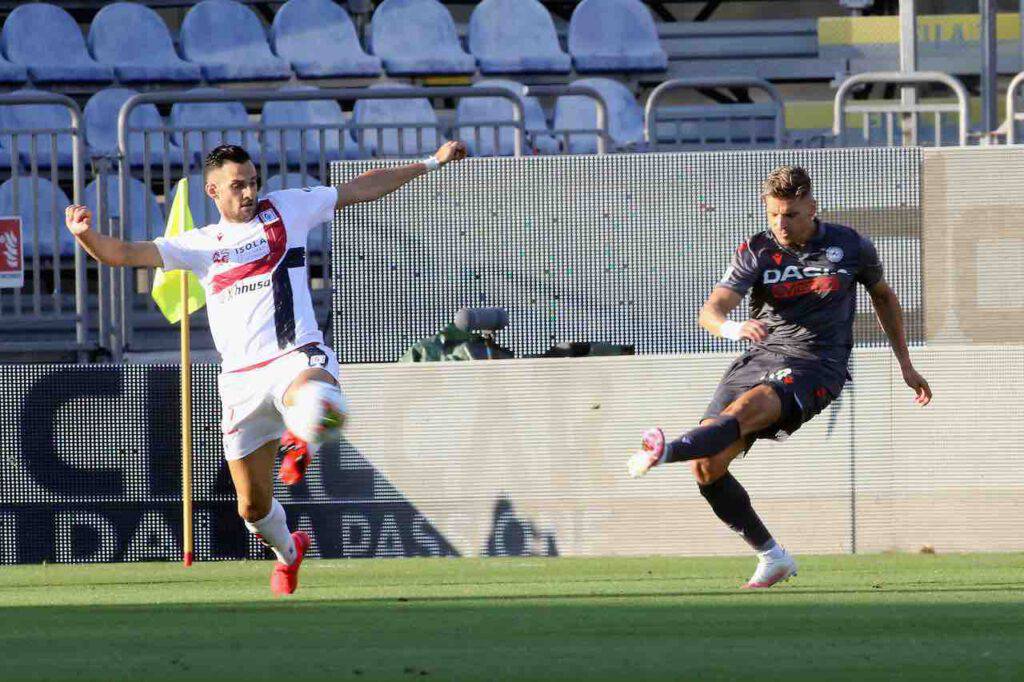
left=469, top=0, right=572, bottom=74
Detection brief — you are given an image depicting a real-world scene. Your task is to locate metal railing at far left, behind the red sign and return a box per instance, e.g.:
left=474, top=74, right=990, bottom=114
left=0, top=92, right=89, bottom=359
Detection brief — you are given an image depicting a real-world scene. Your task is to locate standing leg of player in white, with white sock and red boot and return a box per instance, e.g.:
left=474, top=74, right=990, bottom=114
left=227, top=440, right=309, bottom=594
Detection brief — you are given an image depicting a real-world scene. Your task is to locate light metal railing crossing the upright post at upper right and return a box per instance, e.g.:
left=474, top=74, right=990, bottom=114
left=833, top=71, right=971, bottom=146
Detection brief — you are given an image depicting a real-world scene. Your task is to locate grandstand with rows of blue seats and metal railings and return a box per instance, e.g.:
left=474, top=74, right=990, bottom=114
left=0, top=0, right=1024, bottom=361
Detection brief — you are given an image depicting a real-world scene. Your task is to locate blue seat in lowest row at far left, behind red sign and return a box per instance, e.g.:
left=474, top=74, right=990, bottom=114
left=0, top=176, right=75, bottom=258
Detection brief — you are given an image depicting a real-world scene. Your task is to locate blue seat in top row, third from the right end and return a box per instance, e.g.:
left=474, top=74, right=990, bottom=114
left=370, top=0, right=476, bottom=76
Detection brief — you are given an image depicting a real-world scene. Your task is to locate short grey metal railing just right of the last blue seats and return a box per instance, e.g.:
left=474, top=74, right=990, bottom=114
left=643, top=76, right=785, bottom=151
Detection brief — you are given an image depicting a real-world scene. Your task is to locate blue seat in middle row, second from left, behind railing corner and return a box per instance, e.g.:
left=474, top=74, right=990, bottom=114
left=84, top=88, right=187, bottom=166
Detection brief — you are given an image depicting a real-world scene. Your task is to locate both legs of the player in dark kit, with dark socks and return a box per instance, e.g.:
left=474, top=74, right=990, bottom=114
left=630, top=384, right=797, bottom=588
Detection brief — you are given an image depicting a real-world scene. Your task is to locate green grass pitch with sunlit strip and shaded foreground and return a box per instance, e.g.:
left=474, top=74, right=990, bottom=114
left=0, top=554, right=1024, bottom=682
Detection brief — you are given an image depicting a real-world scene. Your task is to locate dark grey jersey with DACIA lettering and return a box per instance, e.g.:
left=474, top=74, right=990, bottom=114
left=718, top=222, right=882, bottom=367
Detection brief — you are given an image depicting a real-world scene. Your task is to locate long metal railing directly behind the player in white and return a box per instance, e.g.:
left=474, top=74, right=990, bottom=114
left=116, top=87, right=524, bottom=358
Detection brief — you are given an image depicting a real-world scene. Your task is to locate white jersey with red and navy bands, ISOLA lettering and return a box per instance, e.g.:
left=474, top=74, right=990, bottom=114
left=154, top=186, right=338, bottom=372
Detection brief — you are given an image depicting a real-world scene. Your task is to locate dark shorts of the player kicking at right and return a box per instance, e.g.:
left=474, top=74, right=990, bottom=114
left=701, top=348, right=849, bottom=450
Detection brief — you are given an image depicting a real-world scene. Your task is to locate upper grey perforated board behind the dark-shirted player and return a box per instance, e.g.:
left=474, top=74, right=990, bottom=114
left=332, top=148, right=924, bottom=363
